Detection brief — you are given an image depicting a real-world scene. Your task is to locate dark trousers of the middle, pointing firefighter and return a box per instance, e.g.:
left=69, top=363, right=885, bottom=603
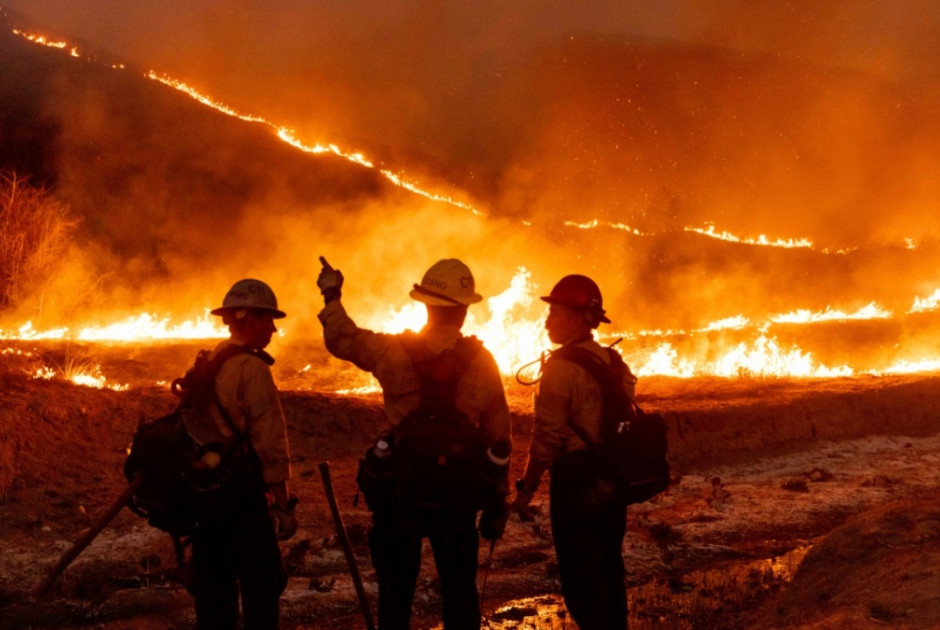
left=369, top=509, right=480, bottom=630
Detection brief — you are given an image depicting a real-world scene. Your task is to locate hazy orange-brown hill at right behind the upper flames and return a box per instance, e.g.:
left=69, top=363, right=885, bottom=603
left=484, top=35, right=940, bottom=247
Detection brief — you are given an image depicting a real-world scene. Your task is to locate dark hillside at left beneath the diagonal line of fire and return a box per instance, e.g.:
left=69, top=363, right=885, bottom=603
left=0, top=23, right=404, bottom=272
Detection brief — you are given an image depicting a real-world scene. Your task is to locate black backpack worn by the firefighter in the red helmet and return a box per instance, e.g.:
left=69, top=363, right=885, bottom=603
left=551, top=346, right=669, bottom=505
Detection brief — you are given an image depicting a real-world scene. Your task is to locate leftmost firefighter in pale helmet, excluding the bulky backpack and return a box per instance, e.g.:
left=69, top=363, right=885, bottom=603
left=186, top=279, right=297, bottom=630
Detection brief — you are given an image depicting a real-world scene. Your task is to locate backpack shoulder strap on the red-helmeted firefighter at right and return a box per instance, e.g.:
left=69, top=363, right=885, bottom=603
left=549, top=346, right=636, bottom=446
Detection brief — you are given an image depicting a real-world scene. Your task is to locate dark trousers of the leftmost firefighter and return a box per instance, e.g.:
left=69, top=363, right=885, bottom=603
left=191, top=495, right=287, bottom=630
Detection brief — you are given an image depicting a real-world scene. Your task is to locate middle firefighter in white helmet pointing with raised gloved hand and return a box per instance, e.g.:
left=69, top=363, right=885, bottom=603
left=317, top=258, right=511, bottom=630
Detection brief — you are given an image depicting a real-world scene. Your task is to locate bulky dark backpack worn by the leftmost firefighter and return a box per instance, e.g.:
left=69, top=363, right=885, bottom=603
left=124, top=345, right=273, bottom=542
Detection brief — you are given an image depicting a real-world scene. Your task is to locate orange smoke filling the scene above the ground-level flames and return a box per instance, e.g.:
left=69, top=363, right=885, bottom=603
left=4, top=0, right=940, bottom=346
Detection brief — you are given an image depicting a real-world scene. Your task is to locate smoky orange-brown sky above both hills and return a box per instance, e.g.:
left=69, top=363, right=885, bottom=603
left=5, top=0, right=940, bottom=172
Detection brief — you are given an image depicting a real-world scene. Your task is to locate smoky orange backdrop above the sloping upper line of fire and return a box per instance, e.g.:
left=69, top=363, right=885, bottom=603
left=3, top=0, right=940, bottom=235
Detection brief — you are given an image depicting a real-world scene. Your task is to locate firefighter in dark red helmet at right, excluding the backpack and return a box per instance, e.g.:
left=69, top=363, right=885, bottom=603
left=512, top=275, right=636, bottom=630
